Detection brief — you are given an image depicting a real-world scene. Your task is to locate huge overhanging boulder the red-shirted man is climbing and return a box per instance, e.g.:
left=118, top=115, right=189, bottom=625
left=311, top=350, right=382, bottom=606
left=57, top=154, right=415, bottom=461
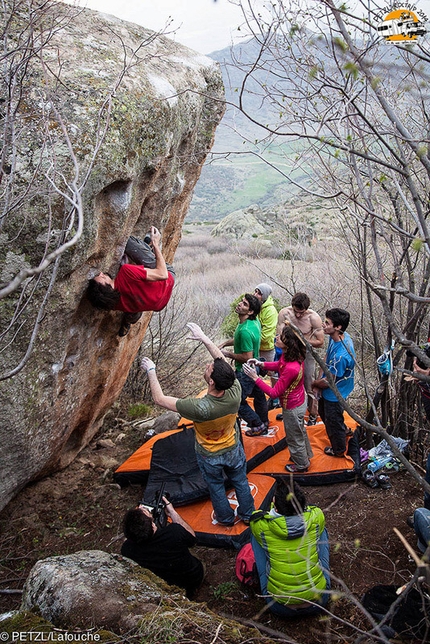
left=0, top=2, right=224, bottom=509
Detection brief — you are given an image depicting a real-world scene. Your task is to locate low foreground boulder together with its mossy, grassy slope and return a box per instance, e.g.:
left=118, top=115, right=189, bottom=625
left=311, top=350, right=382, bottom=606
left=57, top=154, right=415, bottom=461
left=15, top=550, right=275, bottom=644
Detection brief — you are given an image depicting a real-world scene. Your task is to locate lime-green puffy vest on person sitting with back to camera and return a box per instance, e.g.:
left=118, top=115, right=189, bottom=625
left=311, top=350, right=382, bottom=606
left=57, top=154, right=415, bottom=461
left=251, top=505, right=326, bottom=605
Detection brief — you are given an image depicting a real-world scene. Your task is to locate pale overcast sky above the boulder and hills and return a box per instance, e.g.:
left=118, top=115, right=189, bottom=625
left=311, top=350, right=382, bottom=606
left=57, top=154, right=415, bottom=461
left=74, top=0, right=430, bottom=54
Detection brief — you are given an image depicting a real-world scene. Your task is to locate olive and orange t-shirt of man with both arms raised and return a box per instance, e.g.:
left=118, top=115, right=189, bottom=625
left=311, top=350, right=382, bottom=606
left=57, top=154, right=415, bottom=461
left=176, top=380, right=242, bottom=456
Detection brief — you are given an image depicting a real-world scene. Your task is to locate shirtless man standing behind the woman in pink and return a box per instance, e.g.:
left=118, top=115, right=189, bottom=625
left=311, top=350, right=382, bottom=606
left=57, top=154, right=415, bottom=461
left=276, top=293, right=324, bottom=425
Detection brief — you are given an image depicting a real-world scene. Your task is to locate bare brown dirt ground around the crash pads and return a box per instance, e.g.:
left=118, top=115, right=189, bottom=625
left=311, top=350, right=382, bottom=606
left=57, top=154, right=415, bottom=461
left=0, top=414, right=422, bottom=644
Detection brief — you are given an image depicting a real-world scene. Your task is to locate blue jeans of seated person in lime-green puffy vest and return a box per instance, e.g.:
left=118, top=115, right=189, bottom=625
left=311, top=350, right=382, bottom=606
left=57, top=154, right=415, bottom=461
left=251, top=529, right=331, bottom=617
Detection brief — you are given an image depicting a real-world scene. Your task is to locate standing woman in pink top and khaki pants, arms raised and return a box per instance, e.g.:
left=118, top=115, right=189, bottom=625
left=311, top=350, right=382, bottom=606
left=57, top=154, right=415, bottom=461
left=243, top=325, right=313, bottom=473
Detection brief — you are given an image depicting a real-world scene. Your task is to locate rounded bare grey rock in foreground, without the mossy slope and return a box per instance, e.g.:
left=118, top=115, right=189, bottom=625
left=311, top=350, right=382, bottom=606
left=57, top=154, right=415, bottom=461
left=21, top=550, right=183, bottom=632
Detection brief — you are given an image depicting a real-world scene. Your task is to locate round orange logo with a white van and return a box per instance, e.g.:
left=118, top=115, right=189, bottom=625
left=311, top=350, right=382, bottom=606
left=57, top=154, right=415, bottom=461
left=377, top=2, right=427, bottom=43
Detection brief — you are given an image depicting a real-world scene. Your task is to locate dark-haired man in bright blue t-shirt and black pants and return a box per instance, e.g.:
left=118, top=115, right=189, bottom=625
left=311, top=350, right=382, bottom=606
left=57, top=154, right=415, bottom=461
left=312, top=309, right=355, bottom=456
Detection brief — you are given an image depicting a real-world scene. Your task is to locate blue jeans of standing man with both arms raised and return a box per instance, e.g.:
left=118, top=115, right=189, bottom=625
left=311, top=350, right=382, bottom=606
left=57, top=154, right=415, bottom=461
left=196, top=443, right=255, bottom=523
